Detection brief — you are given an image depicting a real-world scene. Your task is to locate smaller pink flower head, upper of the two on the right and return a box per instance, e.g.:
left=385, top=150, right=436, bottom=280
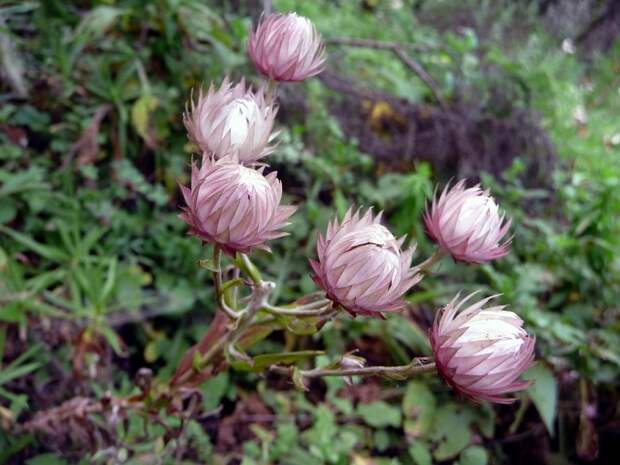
left=424, top=181, right=511, bottom=263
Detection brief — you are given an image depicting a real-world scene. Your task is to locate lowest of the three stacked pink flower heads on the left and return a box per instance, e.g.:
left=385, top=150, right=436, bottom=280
left=180, top=156, right=295, bottom=255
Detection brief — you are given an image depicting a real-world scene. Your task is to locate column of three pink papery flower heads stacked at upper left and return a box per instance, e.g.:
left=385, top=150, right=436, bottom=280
left=180, top=13, right=325, bottom=256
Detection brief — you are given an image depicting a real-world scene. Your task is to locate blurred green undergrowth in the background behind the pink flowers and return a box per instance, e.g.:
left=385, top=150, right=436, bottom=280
left=0, top=0, right=620, bottom=465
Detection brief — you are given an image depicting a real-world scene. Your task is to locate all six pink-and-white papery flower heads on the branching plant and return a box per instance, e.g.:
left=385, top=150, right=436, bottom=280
left=180, top=13, right=534, bottom=403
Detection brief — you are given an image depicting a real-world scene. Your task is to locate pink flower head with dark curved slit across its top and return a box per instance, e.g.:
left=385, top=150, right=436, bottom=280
left=310, top=209, right=422, bottom=316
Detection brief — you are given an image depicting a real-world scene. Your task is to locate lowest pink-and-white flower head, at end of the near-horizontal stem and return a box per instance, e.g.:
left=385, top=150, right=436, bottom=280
left=430, top=293, right=535, bottom=404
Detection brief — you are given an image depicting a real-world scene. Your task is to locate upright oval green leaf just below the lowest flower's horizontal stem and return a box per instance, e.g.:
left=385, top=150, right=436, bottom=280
left=403, top=381, right=436, bottom=437
